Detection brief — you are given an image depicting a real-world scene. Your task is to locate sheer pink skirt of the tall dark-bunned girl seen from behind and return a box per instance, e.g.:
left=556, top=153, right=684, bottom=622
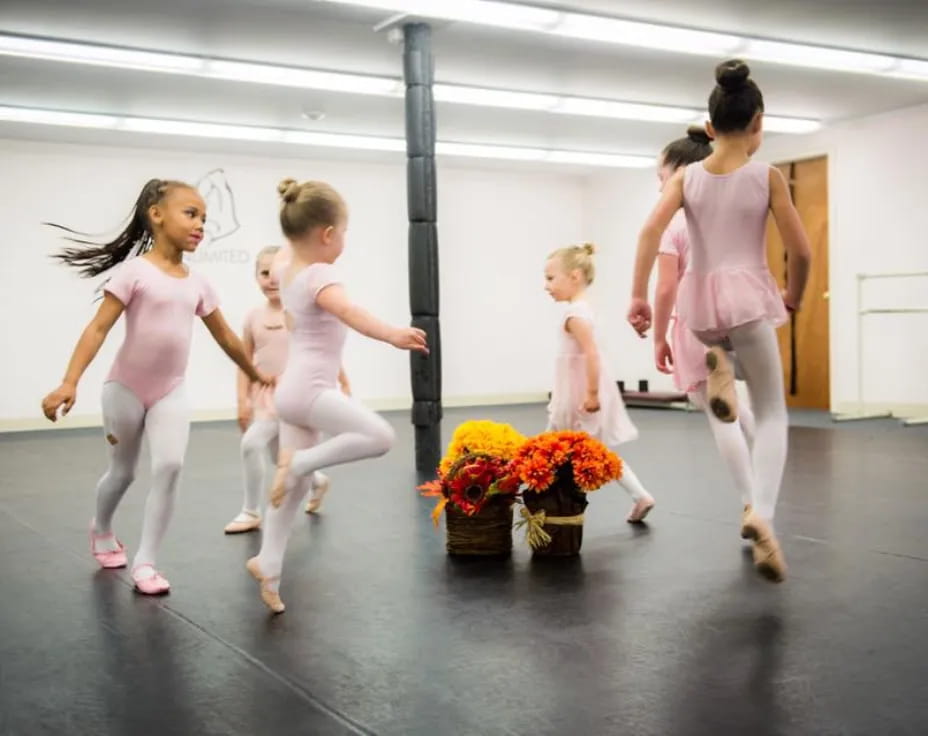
left=677, top=265, right=787, bottom=333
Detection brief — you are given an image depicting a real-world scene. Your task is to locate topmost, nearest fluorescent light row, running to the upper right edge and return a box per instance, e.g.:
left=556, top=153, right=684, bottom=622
left=316, top=0, right=928, bottom=81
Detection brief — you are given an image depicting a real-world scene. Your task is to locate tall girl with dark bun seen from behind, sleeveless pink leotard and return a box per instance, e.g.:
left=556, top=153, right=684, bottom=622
left=628, top=60, right=810, bottom=582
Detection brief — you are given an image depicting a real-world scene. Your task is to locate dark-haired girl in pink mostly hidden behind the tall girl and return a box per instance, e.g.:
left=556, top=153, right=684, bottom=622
left=654, top=126, right=754, bottom=513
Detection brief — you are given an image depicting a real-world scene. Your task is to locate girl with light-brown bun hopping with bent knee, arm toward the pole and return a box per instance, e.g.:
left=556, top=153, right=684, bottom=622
left=246, top=179, right=428, bottom=613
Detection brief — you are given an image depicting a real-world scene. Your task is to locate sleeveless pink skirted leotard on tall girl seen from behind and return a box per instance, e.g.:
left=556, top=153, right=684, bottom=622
left=677, top=161, right=787, bottom=335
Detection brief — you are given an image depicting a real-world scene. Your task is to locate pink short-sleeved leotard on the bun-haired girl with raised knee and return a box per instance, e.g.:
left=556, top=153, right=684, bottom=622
left=274, top=263, right=347, bottom=426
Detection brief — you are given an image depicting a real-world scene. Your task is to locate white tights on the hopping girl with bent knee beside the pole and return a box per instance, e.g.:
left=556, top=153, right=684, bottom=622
left=258, top=389, right=395, bottom=578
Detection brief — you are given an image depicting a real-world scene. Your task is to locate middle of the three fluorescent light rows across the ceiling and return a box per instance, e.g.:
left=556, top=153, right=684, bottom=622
left=0, top=34, right=824, bottom=133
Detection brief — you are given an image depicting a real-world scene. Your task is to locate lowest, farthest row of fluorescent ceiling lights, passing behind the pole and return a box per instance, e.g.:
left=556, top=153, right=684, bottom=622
left=0, top=106, right=654, bottom=167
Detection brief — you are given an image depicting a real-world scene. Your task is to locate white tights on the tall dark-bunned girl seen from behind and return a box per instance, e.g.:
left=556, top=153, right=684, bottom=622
left=696, top=321, right=788, bottom=523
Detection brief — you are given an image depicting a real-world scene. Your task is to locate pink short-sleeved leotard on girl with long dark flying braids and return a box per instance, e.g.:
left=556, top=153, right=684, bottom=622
left=103, top=257, right=218, bottom=409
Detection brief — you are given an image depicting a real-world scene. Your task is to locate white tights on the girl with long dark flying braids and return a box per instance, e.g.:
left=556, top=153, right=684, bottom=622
left=94, top=381, right=190, bottom=569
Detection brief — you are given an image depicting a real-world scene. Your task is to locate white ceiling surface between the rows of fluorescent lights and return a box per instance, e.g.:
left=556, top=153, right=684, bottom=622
left=0, top=0, right=928, bottom=164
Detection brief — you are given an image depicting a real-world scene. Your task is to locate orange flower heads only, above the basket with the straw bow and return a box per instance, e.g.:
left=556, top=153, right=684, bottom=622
left=509, top=432, right=622, bottom=493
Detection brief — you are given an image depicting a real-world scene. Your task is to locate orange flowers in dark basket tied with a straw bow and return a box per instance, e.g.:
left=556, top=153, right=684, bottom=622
left=509, top=432, right=622, bottom=556
